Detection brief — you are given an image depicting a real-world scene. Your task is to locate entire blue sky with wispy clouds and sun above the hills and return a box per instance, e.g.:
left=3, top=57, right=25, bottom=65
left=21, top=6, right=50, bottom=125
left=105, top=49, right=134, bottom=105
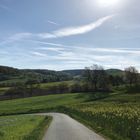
left=0, top=0, right=140, bottom=70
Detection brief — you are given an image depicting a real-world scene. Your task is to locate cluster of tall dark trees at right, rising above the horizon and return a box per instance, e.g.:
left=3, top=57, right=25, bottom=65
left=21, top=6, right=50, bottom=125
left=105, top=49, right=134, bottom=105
left=83, top=65, right=140, bottom=91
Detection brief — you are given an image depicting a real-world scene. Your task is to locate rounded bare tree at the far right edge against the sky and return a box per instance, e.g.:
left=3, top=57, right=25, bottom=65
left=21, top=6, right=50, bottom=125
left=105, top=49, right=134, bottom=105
left=125, top=66, right=139, bottom=86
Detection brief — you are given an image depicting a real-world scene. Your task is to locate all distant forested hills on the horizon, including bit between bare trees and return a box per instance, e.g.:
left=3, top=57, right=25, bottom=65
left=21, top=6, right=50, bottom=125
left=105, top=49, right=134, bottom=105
left=0, top=66, right=123, bottom=87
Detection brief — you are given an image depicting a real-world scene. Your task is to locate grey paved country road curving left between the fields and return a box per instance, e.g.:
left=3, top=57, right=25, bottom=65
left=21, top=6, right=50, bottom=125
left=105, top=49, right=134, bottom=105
left=38, top=113, right=105, bottom=140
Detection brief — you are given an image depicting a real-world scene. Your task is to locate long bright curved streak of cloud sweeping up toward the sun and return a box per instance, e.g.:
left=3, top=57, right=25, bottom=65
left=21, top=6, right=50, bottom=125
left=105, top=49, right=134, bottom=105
left=0, top=15, right=114, bottom=46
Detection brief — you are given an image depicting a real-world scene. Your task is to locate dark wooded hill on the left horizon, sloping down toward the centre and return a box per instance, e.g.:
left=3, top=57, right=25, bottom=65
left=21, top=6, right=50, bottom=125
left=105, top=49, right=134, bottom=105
left=0, top=66, right=72, bottom=86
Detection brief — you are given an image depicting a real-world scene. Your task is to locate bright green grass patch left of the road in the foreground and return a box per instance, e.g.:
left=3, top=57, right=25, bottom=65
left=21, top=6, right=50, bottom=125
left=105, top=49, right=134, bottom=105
left=0, top=115, right=50, bottom=140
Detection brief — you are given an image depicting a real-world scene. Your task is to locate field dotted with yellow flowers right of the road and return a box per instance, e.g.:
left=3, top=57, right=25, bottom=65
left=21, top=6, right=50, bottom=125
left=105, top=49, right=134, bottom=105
left=61, top=95, right=140, bottom=140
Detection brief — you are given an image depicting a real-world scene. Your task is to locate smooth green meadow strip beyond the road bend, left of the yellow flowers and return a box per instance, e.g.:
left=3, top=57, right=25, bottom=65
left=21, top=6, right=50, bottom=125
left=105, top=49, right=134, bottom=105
left=0, top=93, right=99, bottom=115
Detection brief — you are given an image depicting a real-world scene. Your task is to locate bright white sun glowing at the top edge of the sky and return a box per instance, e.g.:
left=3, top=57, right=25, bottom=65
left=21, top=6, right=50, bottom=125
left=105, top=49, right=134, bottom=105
left=97, top=0, right=121, bottom=7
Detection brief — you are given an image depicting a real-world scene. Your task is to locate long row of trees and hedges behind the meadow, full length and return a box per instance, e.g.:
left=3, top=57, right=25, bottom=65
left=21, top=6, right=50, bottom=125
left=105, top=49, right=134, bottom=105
left=0, top=65, right=140, bottom=99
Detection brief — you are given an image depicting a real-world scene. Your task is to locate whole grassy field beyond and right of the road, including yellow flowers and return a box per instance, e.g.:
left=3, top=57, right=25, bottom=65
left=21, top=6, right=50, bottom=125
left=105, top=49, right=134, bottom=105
left=0, top=93, right=140, bottom=140
